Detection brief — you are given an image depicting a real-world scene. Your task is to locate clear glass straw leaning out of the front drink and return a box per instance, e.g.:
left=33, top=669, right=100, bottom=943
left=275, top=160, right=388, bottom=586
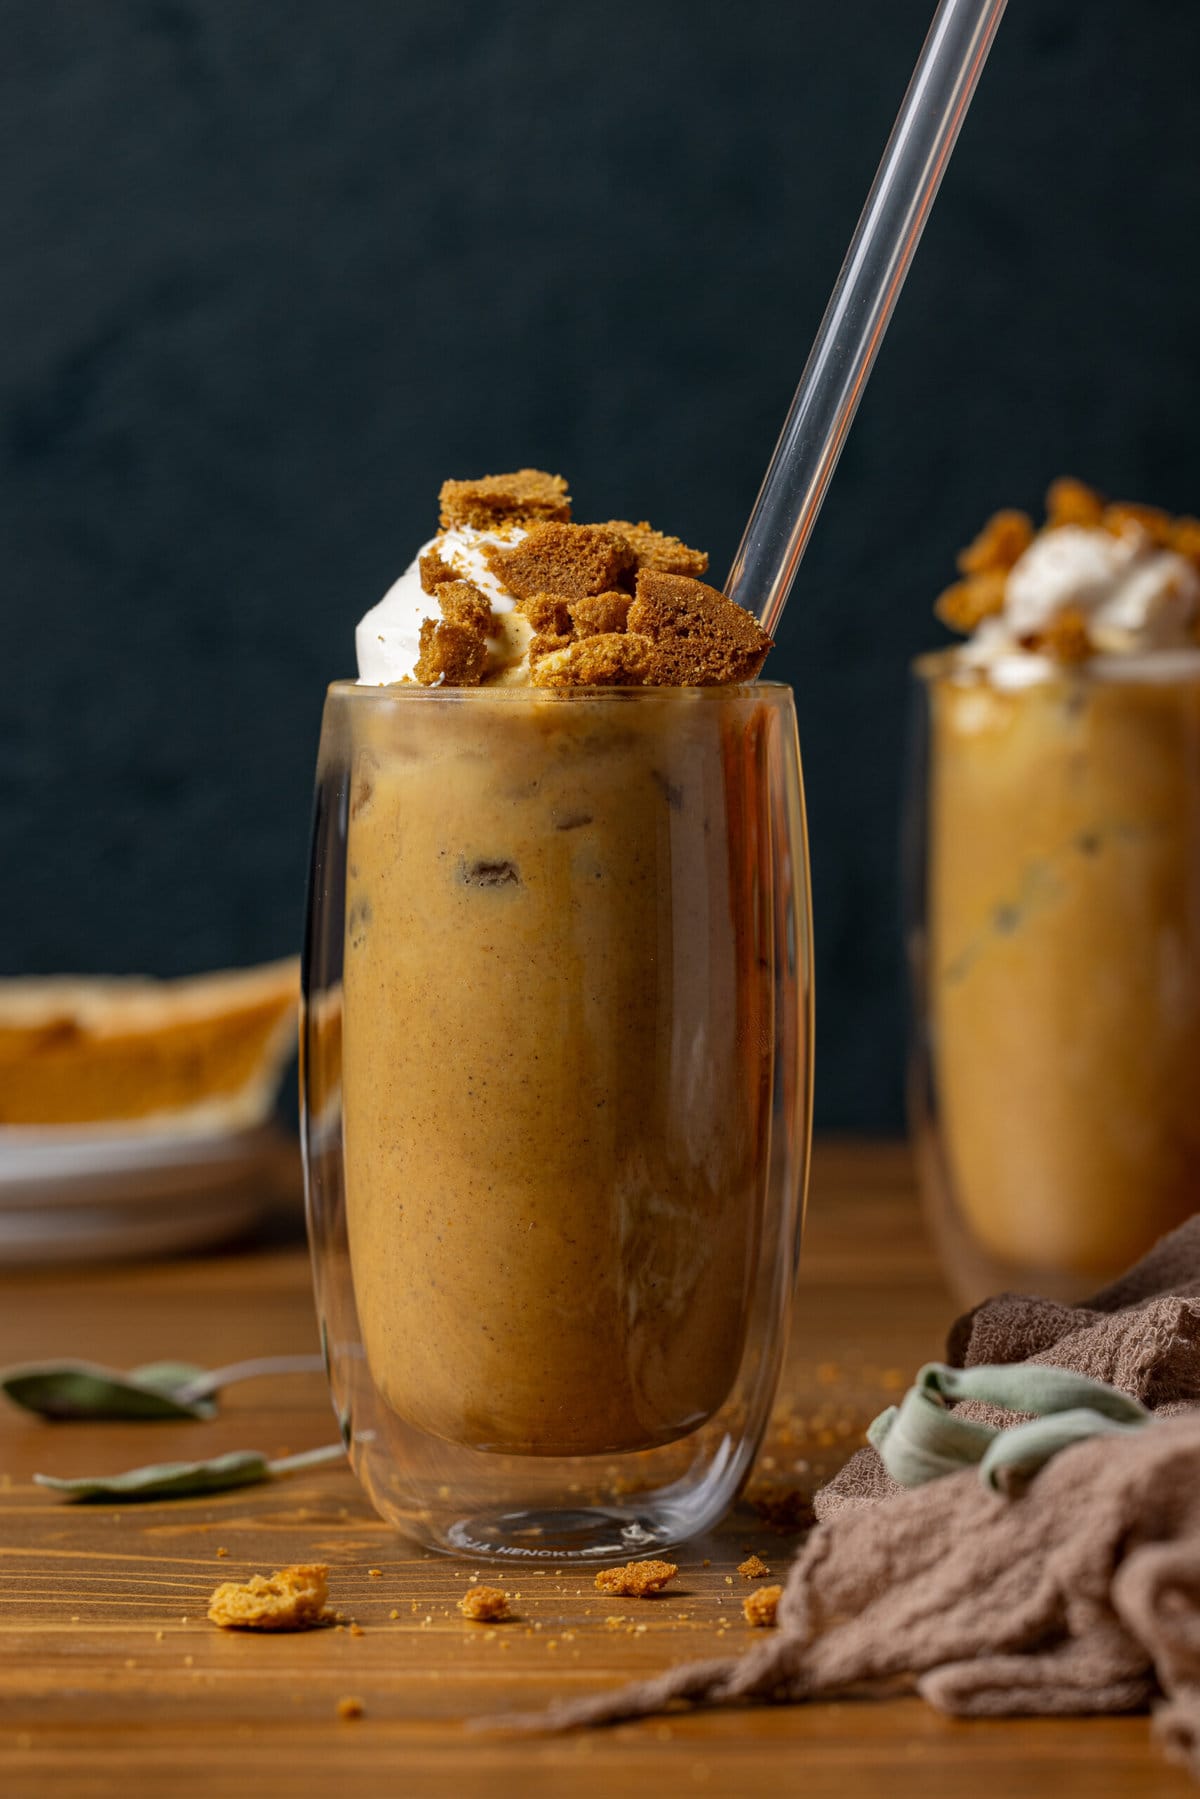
left=725, top=0, right=1006, bottom=635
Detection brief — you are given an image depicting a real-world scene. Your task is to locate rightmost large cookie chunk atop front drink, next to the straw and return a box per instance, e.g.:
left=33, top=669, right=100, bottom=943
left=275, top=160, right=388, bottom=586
left=628, top=568, right=772, bottom=687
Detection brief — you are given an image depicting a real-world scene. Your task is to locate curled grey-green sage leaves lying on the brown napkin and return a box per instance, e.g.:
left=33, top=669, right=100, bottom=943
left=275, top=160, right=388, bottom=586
left=867, top=1362, right=1153, bottom=1491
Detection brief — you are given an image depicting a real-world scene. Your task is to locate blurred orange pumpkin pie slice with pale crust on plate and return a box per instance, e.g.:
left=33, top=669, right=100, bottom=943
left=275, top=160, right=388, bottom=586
left=0, top=957, right=300, bottom=1132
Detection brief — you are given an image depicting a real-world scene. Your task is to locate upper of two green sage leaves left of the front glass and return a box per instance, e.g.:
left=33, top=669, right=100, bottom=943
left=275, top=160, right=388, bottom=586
left=0, top=1355, right=324, bottom=1421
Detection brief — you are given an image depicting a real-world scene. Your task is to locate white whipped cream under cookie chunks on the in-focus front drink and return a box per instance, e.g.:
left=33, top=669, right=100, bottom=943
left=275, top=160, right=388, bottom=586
left=354, top=525, right=531, bottom=687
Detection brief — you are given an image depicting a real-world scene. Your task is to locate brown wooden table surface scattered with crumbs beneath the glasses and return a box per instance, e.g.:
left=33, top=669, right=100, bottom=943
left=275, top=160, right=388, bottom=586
left=0, top=1144, right=1195, bottom=1799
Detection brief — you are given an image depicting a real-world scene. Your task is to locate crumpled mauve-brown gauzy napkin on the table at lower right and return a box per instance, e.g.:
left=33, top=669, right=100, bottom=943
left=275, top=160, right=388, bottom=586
left=509, top=1216, right=1200, bottom=1776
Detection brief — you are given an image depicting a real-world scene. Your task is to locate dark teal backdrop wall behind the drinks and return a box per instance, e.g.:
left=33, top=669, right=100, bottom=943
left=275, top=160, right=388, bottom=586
left=0, top=0, right=1200, bottom=1128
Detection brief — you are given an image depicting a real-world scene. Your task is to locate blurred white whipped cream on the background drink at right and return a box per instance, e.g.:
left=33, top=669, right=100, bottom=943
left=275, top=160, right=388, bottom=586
left=959, top=525, right=1200, bottom=687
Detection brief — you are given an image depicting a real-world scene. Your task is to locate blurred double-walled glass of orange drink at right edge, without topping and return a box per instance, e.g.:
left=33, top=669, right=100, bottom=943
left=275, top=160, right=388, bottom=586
left=909, top=651, right=1200, bottom=1302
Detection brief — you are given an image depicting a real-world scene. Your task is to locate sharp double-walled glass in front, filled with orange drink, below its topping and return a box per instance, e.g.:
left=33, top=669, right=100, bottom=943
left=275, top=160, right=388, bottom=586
left=302, top=684, right=811, bottom=1562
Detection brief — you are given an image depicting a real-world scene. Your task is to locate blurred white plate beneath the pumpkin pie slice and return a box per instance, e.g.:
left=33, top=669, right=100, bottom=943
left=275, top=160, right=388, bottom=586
left=0, top=1124, right=295, bottom=1266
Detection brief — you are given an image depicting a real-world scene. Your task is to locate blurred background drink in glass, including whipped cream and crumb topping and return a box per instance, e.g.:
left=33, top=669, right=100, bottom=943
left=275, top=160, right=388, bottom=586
left=919, top=482, right=1200, bottom=1297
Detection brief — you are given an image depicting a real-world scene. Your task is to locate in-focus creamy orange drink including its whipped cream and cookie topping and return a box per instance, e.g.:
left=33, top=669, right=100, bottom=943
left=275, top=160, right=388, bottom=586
left=342, top=471, right=772, bottom=1455
